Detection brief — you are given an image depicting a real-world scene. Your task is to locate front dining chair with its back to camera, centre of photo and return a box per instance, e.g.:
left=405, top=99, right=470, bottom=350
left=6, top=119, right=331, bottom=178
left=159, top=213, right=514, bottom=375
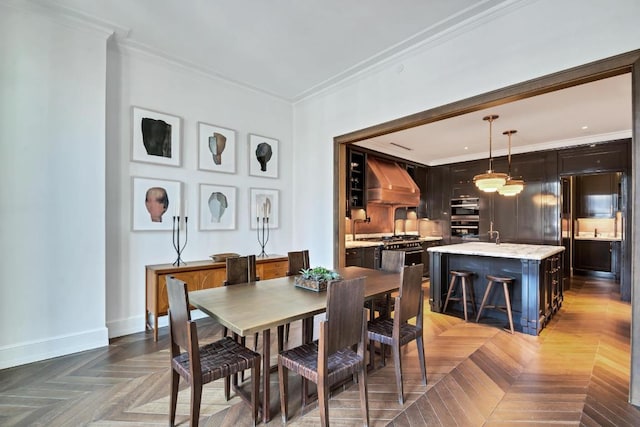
left=278, top=277, right=369, bottom=426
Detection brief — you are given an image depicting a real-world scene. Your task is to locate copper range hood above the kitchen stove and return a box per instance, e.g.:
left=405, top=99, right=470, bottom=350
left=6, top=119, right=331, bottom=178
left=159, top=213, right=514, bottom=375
left=367, top=157, right=420, bottom=206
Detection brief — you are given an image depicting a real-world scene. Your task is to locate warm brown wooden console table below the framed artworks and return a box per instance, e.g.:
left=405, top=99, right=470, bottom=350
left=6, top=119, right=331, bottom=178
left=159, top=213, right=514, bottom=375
left=145, top=255, right=289, bottom=341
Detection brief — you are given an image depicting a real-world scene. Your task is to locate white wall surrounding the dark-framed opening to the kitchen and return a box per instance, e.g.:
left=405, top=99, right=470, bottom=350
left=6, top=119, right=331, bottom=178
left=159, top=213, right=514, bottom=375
left=293, top=0, right=640, bottom=264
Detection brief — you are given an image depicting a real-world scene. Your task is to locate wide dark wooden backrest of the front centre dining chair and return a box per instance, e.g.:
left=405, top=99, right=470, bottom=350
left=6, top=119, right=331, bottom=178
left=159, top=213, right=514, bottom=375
left=326, top=277, right=365, bottom=355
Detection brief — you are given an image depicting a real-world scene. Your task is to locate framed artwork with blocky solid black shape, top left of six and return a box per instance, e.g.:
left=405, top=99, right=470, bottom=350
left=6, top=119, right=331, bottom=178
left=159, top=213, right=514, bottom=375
left=131, top=107, right=182, bottom=166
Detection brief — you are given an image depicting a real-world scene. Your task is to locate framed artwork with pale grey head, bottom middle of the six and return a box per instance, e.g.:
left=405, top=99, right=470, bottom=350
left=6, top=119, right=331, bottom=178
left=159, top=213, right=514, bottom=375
left=200, top=184, right=237, bottom=230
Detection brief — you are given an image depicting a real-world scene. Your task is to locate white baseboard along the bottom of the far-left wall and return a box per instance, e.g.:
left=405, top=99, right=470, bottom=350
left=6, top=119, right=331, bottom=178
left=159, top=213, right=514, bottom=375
left=0, top=328, right=109, bottom=369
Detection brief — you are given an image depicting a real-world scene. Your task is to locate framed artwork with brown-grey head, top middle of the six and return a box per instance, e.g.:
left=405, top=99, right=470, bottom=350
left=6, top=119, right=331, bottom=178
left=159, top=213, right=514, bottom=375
left=198, top=122, right=236, bottom=173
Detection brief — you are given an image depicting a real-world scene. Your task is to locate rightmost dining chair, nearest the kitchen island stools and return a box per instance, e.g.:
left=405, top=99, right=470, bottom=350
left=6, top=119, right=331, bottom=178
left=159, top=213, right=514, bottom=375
left=367, top=264, right=427, bottom=405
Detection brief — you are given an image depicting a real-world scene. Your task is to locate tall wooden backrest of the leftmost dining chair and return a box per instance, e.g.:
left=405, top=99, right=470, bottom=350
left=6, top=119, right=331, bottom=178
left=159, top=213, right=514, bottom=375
left=167, top=276, right=191, bottom=350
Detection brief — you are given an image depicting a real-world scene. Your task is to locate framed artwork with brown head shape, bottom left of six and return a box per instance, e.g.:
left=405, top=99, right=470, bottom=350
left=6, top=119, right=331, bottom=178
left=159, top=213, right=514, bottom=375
left=131, top=177, right=182, bottom=231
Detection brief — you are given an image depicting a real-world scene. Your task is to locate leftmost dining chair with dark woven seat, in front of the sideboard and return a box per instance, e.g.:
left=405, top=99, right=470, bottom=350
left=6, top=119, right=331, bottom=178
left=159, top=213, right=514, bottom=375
left=167, top=277, right=260, bottom=427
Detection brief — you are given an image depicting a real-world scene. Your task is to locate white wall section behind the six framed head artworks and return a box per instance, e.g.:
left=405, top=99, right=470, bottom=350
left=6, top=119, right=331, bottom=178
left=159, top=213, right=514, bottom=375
left=106, top=47, right=294, bottom=337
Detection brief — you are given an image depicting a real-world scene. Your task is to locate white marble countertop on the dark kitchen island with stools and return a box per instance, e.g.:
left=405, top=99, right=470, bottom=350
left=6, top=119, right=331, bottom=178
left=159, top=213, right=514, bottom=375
left=427, top=242, right=564, bottom=260
